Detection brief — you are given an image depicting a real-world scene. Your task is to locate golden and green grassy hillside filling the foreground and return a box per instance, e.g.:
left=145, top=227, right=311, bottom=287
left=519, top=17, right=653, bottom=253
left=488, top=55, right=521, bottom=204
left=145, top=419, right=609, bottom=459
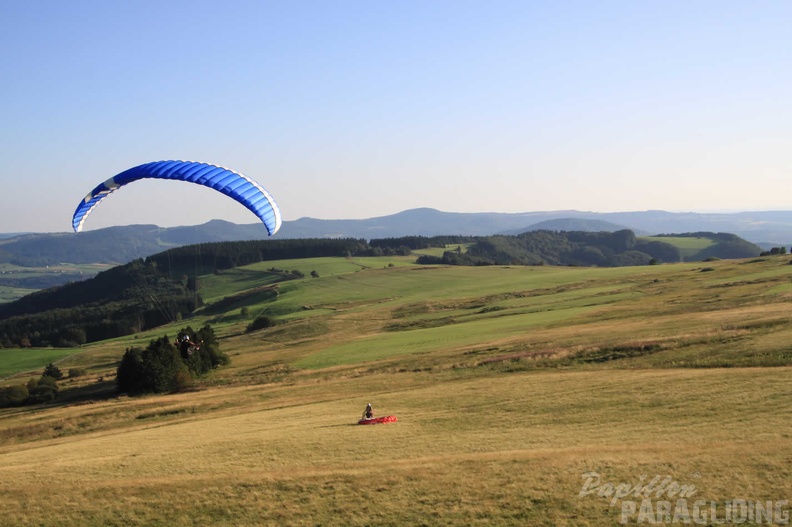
left=0, top=257, right=792, bottom=526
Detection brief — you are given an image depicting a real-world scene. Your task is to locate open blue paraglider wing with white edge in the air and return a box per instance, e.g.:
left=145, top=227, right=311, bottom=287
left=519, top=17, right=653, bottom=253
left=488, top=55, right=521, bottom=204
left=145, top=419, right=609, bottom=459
left=72, top=161, right=282, bottom=236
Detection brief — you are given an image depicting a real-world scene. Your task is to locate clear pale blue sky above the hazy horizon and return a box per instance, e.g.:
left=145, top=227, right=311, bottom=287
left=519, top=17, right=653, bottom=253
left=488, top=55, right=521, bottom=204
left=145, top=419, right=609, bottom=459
left=0, top=0, right=792, bottom=232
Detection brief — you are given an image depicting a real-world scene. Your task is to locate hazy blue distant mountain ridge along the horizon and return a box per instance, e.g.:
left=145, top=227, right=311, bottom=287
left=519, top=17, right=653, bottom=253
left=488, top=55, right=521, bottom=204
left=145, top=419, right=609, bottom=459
left=0, top=208, right=792, bottom=266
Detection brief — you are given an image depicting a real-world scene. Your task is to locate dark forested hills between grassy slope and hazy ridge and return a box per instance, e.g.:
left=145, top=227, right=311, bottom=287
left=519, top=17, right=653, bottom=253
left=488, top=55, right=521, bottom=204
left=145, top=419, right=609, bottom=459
left=0, top=230, right=760, bottom=347
